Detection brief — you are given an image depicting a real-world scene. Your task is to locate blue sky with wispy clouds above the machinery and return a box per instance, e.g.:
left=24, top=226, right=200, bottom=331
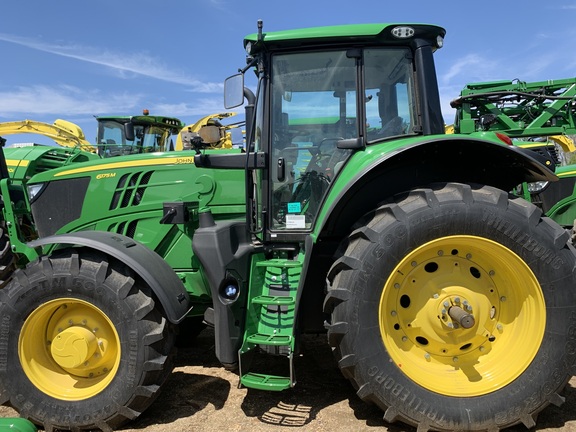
left=0, top=0, right=576, bottom=144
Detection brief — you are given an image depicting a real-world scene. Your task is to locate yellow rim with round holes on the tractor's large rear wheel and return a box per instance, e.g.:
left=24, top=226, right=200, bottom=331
left=379, top=236, right=546, bottom=397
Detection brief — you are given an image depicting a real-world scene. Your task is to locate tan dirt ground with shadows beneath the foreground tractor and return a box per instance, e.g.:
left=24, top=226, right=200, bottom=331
left=0, top=330, right=576, bottom=432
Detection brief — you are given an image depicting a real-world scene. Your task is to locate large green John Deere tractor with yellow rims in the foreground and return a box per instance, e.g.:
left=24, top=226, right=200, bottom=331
left=0, top=22, right=576, bottom=431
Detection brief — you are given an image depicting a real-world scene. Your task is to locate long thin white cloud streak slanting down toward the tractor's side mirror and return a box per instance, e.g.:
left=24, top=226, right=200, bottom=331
left=0, top=33, right=222, bottom=93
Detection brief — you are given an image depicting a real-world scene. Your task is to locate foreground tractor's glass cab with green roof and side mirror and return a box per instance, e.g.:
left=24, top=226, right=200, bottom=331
left=209, top=25, right=444, bottom=241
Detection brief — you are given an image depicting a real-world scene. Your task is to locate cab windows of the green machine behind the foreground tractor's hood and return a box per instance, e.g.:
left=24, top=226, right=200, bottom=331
left=97, top=120, right=171, bottom=158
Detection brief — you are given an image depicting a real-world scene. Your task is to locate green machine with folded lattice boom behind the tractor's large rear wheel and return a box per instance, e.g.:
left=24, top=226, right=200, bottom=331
left=451, top=78, right=576, bottom=230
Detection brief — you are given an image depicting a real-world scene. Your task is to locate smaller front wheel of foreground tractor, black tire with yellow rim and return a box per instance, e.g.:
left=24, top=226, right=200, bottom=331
left=0, top=251, right=174, bottom=431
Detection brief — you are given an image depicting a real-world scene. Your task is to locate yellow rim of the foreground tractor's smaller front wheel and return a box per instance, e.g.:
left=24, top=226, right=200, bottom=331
left=18, top=298, right=120, bottom=400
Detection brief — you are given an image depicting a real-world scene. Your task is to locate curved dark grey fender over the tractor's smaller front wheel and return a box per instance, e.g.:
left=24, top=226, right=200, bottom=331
left=28, top=231, right=191, bottom=324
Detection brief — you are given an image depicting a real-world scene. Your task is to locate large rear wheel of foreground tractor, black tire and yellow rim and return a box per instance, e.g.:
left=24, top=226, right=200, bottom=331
left=325, top=184, right=576, bottom=431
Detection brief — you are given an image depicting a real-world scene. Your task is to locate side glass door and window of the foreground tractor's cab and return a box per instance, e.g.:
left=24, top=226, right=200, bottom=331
left=270, top=48, right=416, bottom=230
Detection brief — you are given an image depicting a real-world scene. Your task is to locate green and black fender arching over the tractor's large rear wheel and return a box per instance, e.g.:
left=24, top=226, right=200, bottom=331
left=317, top=135, right=558, bottom=237
